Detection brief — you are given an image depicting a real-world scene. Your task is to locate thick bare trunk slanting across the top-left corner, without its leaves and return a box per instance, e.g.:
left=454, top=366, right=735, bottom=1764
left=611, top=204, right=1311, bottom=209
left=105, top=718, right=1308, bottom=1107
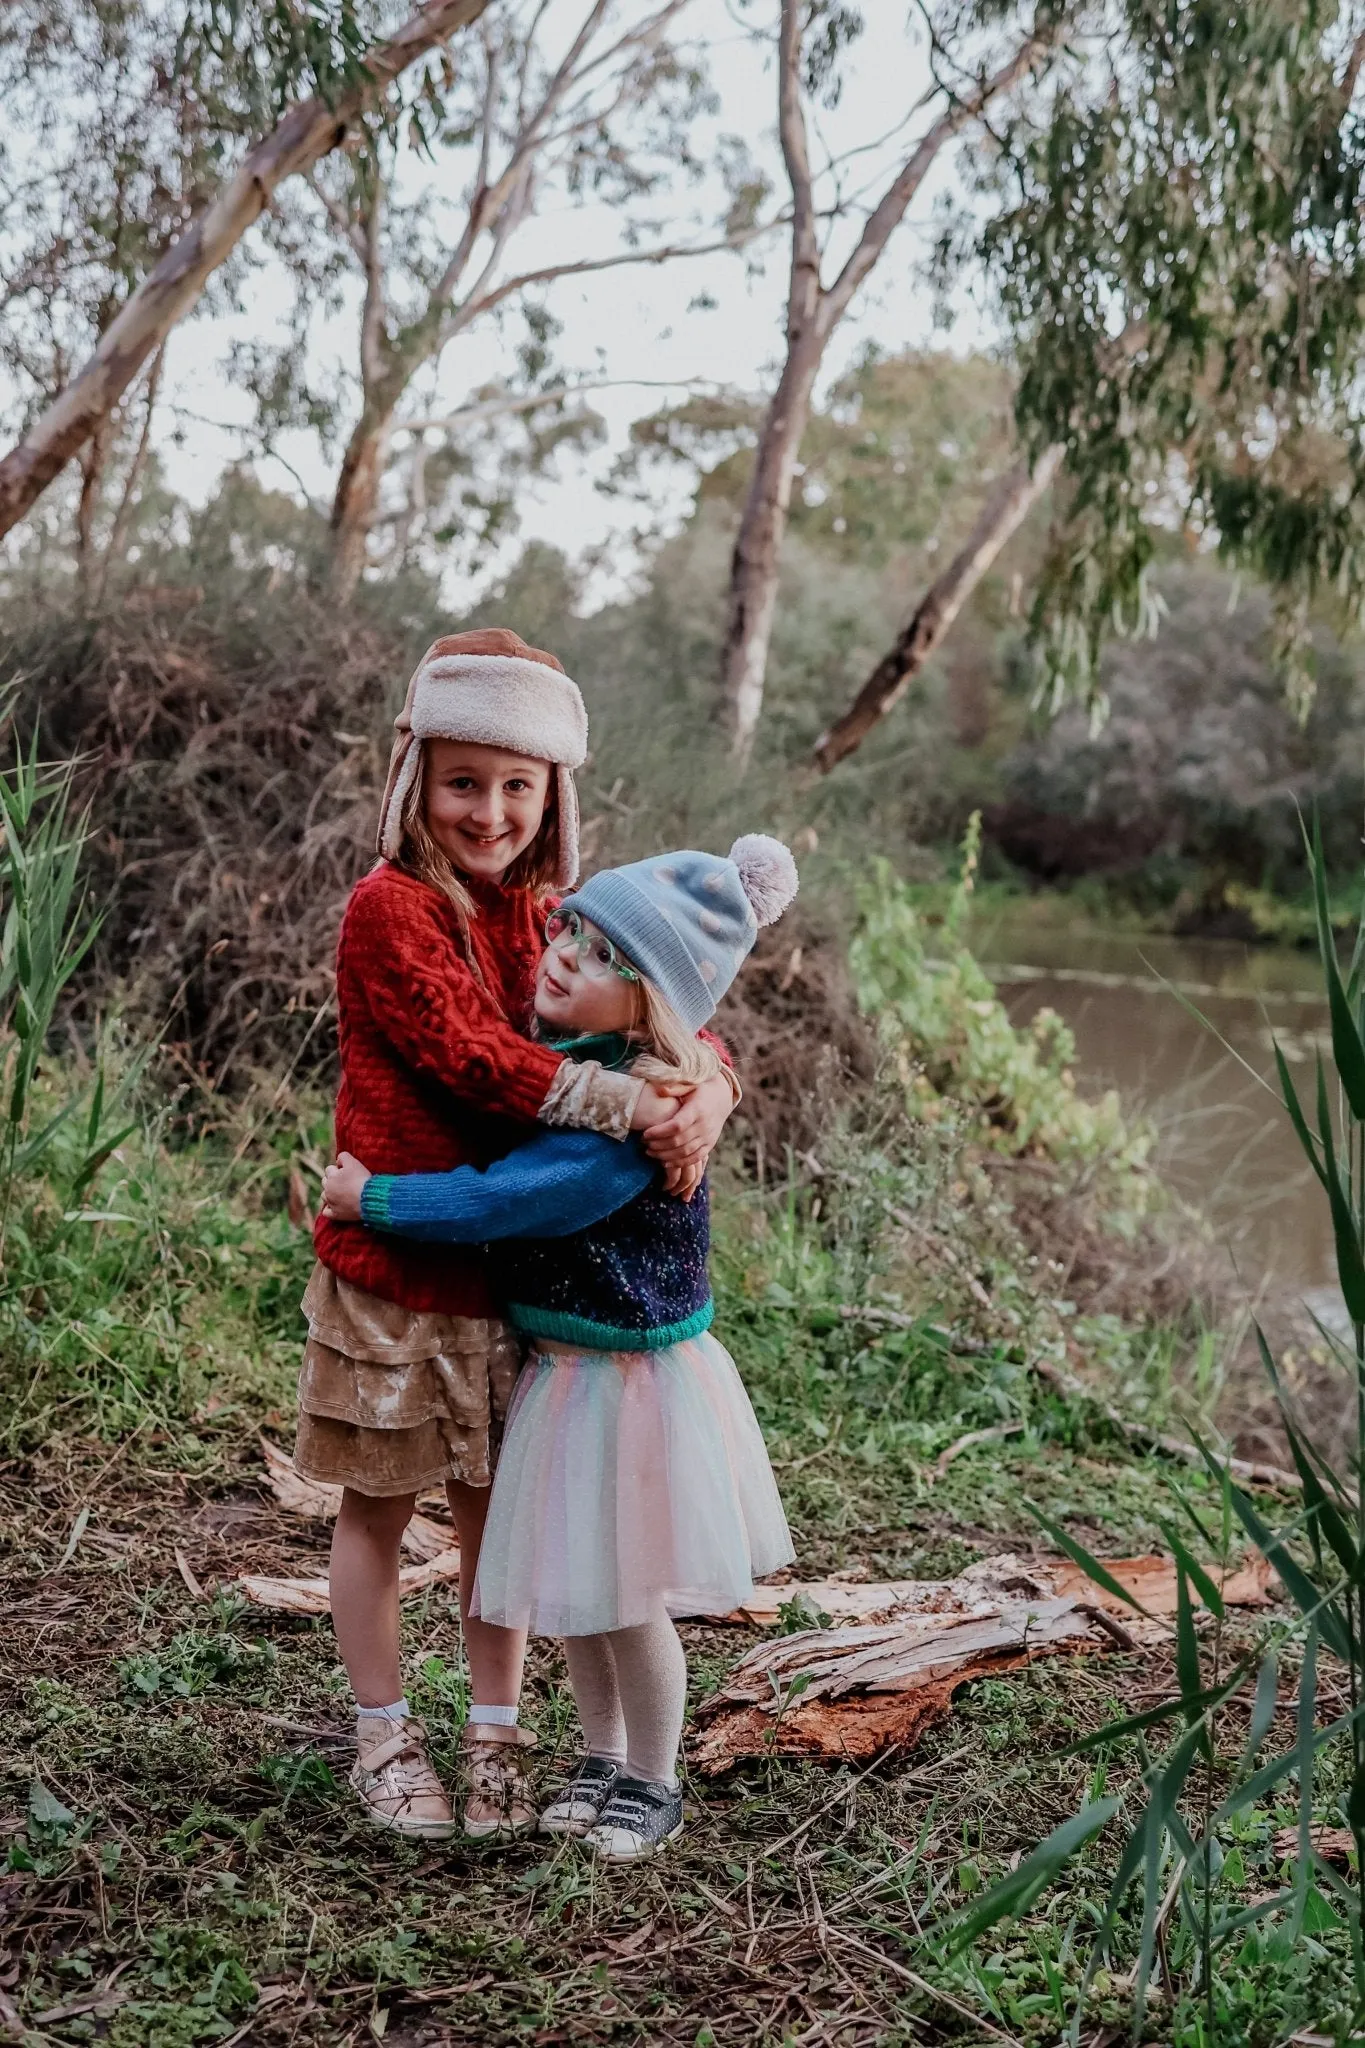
left=0, top=0, right=489, bottom=535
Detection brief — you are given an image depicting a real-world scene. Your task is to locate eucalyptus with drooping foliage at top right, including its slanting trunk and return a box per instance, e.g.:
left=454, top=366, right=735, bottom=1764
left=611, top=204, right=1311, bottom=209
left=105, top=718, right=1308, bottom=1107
left=817, top=0, right=1365, bottom=768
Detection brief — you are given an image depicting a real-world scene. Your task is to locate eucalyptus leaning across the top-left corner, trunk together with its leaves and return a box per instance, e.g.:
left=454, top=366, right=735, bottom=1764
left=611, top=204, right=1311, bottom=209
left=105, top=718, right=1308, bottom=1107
left=0, top=0, right=489, bottom=535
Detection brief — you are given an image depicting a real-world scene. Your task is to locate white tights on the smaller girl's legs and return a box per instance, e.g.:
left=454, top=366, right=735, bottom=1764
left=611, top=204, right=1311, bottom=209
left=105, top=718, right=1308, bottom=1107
left=565, top=1608, right=688, bottom=1784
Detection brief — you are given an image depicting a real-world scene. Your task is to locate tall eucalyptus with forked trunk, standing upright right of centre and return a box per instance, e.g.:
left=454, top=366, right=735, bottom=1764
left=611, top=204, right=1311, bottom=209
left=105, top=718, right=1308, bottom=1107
left=718, top=0, right=1062, bottom=760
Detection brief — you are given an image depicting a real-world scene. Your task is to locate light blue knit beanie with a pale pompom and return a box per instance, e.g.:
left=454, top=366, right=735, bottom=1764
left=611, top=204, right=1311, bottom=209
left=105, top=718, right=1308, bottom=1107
left=563, top=831, right=796, bottom=1030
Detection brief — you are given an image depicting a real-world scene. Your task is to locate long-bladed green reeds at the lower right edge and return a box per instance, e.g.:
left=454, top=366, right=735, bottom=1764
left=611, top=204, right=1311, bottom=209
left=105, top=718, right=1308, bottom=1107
left=937, top=819, right=1365, bottom=2042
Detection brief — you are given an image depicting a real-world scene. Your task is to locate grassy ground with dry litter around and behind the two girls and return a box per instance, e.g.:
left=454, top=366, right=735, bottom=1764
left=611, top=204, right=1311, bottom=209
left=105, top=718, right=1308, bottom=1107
left=0, top=1081, right=1351, bottom=2048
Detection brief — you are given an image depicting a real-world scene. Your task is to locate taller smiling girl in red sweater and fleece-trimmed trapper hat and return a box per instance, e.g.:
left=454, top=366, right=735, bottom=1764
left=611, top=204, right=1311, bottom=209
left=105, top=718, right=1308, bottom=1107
left=297, top=631, right=733, bottom=1839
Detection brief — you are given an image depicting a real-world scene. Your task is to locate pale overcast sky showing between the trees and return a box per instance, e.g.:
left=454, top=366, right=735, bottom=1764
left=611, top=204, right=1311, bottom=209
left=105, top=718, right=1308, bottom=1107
left=154, top=0, right=998, bottom=596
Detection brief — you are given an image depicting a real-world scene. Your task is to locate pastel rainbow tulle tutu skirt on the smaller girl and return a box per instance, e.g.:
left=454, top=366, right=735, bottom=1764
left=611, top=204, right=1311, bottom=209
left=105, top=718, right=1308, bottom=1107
left=473, top=1335, right=794, bottom=1636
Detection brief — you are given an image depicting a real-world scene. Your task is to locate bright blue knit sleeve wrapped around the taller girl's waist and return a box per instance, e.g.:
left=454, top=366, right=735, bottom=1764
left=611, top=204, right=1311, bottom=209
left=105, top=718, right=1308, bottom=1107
left=351, top=1130, right=655, bottom=1245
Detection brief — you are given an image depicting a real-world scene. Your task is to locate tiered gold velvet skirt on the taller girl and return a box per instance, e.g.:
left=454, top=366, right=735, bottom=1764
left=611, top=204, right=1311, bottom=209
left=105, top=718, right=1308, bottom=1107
left=295, top=1266, right=522, bottom=1499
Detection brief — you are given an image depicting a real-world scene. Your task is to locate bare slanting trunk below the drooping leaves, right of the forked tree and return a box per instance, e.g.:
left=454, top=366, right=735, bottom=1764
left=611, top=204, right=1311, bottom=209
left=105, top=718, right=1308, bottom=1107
left=814, top=442, right=1064, bottom=774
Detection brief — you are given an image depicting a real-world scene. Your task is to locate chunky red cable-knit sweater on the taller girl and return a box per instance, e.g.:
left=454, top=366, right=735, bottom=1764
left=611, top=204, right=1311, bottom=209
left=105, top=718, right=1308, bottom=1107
left=313, top=862, right=561, bottom=1315
